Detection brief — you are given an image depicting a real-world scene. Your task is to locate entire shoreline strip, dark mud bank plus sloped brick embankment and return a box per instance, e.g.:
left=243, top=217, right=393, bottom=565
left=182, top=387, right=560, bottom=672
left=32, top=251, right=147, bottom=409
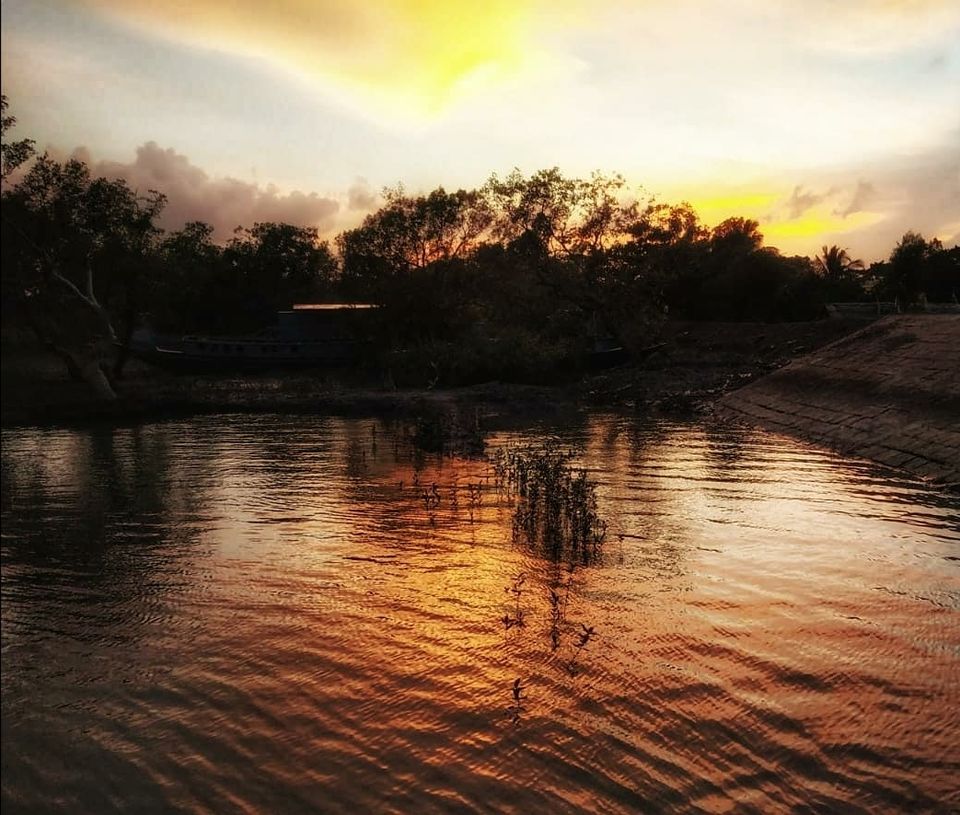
left=0, top=315, right=960, bottom=491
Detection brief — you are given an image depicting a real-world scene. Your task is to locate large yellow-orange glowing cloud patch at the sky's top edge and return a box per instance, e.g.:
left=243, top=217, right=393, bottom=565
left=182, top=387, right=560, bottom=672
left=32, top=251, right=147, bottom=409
left=84, top=0, right=563, bottom=119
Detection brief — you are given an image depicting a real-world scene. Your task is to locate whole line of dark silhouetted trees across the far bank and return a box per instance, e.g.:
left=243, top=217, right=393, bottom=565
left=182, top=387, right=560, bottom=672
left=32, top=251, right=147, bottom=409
left=2, top=97, right=960, bottom=395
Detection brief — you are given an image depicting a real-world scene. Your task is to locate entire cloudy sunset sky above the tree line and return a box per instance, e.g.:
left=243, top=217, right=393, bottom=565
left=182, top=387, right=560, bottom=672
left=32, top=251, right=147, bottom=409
left=0, top=0, right=960, bottom=260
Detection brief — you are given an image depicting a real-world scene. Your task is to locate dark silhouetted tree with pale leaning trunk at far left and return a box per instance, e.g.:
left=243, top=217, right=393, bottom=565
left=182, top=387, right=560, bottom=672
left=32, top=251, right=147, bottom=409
left=3, top=155, right=165, bottom=398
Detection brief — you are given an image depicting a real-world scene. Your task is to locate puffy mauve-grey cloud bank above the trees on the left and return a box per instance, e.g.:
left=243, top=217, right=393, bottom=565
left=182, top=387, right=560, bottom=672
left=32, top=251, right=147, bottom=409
left=82, top=142, right=340, bottom=240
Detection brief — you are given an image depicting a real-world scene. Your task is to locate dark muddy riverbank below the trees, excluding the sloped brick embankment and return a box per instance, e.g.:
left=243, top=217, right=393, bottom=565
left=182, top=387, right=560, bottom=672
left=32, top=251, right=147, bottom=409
left=0, top=320, right=862, bottom=426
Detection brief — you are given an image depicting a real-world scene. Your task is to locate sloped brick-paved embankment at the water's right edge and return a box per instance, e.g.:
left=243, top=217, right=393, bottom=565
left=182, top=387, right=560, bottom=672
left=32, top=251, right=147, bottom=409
left=718, top=315, right=960, bottom=489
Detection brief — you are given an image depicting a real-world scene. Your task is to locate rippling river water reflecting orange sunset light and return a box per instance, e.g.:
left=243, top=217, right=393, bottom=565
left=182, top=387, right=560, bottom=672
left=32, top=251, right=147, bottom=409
left=2, top=415, right=960, bottom=813
